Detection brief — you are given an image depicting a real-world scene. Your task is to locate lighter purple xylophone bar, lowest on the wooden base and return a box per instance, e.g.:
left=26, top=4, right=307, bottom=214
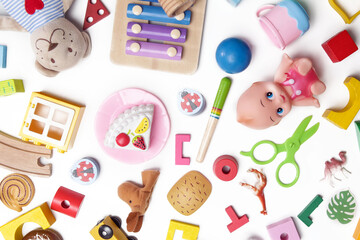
left=125, top=40, right=182, bottom=60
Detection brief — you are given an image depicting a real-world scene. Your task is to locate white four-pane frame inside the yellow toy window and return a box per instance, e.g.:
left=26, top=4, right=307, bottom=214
left=24, top=97, right=75, bottom=146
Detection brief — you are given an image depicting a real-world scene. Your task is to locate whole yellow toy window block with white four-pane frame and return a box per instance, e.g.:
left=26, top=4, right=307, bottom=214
left=19, top=92, right=85, bottom=153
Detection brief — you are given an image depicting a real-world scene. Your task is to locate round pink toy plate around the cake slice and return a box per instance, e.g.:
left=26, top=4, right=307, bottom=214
left=95, top=88, right=170, bottom=164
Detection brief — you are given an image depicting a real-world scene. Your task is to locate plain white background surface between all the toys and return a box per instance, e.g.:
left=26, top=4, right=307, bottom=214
left=0, top=0, right=360, bottom=240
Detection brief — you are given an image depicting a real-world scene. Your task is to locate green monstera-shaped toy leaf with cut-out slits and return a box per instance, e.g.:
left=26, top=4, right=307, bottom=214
left=326, top=190, right=356, bottom=224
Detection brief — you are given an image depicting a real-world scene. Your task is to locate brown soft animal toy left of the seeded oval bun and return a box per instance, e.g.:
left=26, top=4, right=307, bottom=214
left=118, top=170, right=160, bottom=232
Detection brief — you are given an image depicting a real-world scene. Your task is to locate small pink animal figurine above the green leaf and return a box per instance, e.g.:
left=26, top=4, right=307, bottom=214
left=321, top=151, right=351, bottom=187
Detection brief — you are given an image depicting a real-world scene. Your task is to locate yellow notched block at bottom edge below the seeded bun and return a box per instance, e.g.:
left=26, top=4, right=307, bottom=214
left=166, top=220, right=200, bottom=240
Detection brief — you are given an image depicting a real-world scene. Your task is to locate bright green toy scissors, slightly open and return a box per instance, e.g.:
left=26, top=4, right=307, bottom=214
left=240, top=116, right=320, bottom=187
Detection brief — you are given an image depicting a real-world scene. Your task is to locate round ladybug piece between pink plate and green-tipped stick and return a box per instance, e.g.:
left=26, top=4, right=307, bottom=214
left=178, top=88, right=206, bottom=116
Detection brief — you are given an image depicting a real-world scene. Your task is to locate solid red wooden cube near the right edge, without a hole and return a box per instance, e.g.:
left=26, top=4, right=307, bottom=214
left=321, top=30, right=358, bottom=63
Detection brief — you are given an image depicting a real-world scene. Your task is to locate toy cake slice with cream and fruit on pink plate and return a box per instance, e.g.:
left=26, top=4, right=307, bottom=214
left=104, top=104, right=154, bottom=151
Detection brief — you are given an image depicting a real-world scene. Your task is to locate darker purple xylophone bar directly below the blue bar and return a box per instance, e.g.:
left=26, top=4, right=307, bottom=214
left=127, top=22, right=187, bottom=43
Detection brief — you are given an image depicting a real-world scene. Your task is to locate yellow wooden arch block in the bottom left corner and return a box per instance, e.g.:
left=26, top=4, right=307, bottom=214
left=0, top=202, right=56, bottom=240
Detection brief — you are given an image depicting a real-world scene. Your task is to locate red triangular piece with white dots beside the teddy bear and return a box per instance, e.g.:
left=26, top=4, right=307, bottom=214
left=83, top=0, right=110, bottom=30
